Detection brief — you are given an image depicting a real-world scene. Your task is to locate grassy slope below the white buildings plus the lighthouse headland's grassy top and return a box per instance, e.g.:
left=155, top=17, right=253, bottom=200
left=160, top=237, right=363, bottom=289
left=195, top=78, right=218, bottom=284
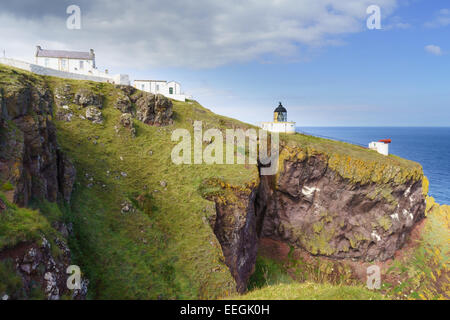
left=0, top=67, right=436, bottom=299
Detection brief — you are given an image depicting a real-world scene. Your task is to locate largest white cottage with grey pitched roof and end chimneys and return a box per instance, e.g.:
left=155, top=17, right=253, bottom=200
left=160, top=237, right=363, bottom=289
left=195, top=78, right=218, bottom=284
left=36, top=46, right=96, bottom=74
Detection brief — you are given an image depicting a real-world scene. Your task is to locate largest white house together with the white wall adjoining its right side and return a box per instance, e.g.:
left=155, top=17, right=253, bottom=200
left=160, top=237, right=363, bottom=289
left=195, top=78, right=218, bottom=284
left=31, top=46, right=130, bottom=85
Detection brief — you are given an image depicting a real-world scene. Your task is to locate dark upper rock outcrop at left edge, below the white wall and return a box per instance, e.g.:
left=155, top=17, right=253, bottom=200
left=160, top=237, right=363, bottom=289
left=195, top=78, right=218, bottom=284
left=0, top=80, right=75, bottom=206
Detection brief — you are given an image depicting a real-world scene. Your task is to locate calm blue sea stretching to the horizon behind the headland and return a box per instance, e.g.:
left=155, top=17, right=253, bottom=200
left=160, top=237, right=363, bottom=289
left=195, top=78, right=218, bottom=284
left=297, top=127, right=450, bottom=204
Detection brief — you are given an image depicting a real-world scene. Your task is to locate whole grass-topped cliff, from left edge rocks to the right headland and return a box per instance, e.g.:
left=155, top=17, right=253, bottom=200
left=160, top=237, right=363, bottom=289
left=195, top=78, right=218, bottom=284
left=0, top=67, right=442, bottom=299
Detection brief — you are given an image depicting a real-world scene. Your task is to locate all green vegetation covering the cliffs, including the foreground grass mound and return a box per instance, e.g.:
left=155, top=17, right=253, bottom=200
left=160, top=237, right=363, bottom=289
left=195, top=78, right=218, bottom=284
left=0, top=67, right=442, bottom=299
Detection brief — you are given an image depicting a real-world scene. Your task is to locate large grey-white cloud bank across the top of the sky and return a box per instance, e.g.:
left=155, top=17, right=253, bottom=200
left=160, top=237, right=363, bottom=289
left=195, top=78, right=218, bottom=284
left=0, top=0, right=397, bottom=68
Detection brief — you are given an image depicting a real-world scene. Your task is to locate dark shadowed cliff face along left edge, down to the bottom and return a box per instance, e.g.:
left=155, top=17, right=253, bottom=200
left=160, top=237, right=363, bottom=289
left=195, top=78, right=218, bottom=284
left=0, top=72, right=82, bottom=299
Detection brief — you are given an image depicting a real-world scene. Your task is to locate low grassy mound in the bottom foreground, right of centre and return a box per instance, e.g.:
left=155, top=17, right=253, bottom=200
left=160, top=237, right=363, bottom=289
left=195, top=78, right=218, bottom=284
left=232, top=282, right=385, bottom=300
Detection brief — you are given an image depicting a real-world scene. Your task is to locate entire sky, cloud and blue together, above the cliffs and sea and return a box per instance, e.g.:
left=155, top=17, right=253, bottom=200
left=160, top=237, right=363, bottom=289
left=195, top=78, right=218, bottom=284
left=0, top=0, right=450, bottom=127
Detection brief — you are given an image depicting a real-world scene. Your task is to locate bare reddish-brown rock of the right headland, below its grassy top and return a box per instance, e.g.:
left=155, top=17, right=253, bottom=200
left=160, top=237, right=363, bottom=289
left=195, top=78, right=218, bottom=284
left=258, top=155, right=425, bottom=261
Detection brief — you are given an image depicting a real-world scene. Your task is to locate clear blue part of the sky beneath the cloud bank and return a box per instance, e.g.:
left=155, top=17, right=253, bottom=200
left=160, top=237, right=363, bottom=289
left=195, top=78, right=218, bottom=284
left=127, top=0, right=450, bottom=126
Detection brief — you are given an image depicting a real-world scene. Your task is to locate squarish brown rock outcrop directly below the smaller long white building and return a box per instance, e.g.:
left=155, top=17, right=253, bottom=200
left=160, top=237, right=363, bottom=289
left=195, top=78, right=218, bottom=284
left=135, top=92, right=173, bottom=126
